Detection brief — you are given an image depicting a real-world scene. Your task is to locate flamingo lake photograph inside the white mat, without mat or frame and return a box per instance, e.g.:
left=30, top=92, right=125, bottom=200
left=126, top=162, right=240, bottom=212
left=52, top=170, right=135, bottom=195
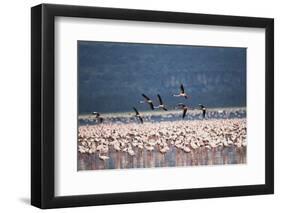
left=77, top=41, right=247, bottom=171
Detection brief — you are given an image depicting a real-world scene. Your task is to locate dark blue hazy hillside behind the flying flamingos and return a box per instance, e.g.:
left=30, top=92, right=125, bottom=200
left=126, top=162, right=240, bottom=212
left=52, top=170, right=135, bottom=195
left=78, top=41, right=246, bottom=113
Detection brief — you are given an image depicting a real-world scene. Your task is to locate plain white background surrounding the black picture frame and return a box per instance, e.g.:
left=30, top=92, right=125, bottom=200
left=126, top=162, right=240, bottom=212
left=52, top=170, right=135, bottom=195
left=0, top=0, right=276, bottom=213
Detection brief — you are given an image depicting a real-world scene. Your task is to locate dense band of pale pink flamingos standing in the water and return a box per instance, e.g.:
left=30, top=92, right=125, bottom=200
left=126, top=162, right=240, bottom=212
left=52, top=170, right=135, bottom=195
left=78, top=118, right=247, bottom=160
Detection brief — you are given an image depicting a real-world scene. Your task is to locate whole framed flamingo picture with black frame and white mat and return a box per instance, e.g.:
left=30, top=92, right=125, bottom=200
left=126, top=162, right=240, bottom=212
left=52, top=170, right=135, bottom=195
left=31, top=4, right=274, bottom=208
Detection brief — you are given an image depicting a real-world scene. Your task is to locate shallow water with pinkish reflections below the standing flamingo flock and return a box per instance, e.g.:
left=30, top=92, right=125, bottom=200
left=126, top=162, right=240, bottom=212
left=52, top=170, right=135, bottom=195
left=78, top=146, right=246, bottom=170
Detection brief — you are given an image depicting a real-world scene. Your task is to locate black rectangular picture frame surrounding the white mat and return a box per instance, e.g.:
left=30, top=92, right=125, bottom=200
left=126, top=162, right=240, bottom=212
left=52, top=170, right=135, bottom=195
left=31, top=4, right=274, bottom=209
